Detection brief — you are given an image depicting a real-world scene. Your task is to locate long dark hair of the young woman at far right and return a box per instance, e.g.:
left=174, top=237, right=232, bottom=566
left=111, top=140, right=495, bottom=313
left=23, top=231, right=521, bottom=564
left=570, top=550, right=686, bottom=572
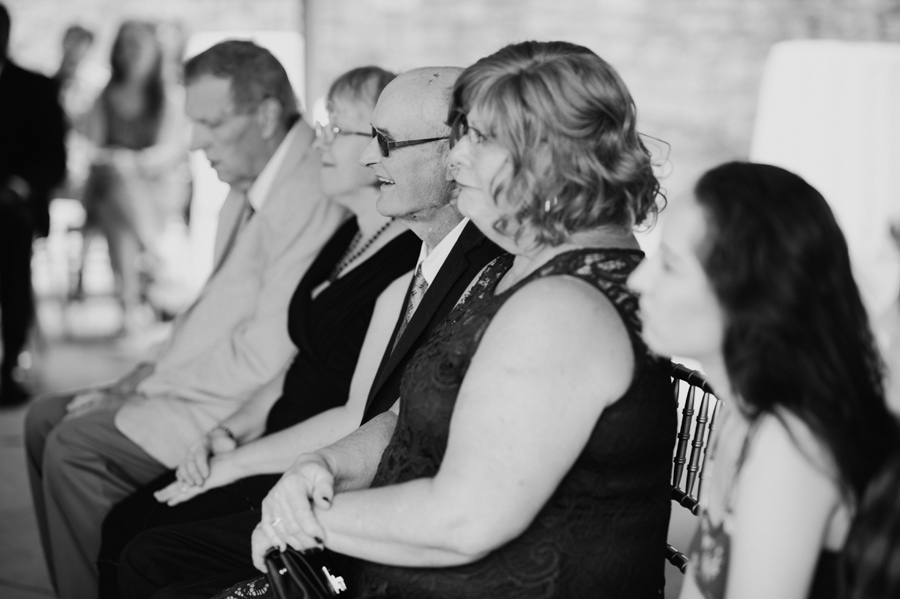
left=695, top=162, right=898, bottom=499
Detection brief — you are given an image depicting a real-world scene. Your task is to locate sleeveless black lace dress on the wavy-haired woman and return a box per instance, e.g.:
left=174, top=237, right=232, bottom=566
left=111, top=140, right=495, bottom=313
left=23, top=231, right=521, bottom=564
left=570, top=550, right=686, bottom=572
left=344, top=249, right=676, bottom=599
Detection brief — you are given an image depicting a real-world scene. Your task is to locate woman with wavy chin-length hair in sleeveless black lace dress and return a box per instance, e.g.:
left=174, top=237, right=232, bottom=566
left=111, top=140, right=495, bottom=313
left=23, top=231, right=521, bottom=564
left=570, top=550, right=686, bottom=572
left=207, top=42, right=675, bottom=599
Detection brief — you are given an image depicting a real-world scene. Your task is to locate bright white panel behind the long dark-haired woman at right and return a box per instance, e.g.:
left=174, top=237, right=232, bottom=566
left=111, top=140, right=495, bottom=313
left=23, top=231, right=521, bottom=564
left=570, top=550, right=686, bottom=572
left=750, top=40, right=900, bottom=317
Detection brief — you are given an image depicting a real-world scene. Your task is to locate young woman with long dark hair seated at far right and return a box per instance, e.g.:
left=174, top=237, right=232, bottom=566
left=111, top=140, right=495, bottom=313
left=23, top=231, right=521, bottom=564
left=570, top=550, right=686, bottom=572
left=629, top=162, right=897, bottom=599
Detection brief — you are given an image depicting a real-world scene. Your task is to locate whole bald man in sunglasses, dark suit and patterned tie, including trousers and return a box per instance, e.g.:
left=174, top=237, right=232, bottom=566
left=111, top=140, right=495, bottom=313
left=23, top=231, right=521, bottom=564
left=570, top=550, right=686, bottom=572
left=119, top=67, right=501, bottom=599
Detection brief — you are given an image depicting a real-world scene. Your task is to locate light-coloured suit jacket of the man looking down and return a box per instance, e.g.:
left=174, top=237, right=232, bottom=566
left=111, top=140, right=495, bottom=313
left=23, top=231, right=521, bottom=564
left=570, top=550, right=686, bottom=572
left=115, top=126, right=346, bottom=468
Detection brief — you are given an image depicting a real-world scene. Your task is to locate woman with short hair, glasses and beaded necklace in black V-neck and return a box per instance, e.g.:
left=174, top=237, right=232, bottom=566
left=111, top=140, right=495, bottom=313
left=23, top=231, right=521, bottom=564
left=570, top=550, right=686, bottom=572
left=98, top=67, right=421, bottom=597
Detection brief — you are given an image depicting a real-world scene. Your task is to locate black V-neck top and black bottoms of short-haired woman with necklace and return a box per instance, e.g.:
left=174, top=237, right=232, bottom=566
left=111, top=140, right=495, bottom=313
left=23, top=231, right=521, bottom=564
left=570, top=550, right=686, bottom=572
left=98, top=219, right=421, bottom=599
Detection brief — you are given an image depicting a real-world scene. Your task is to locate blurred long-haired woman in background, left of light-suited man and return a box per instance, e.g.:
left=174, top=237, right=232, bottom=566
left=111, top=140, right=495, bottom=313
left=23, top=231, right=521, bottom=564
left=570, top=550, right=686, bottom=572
left=82, top=21, right=190, bottom=332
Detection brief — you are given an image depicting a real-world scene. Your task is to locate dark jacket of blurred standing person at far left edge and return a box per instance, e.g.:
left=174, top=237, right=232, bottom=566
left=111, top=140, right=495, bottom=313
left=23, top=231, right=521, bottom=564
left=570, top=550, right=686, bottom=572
left=0, top=61, right=66, bottom=235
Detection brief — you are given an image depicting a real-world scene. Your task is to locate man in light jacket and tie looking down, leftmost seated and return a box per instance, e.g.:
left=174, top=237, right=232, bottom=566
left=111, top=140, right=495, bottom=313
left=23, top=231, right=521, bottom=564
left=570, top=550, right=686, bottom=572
left=26, top=41, right=345, bottom=599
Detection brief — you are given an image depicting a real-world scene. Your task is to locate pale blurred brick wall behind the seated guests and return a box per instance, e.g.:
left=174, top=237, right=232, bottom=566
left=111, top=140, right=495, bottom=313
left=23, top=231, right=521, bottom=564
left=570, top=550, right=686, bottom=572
left=6, top=0, right=900, bottom=203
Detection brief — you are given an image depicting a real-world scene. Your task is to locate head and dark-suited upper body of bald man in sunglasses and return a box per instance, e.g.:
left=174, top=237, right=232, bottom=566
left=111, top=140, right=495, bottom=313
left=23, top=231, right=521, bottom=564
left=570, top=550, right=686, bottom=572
left=360, top=67, right=501, bottom=423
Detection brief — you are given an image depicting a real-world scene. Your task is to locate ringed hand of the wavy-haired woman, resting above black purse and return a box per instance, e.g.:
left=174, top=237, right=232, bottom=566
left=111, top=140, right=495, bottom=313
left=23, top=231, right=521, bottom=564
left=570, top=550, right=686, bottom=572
left=253, top=453, right=334, bottom=567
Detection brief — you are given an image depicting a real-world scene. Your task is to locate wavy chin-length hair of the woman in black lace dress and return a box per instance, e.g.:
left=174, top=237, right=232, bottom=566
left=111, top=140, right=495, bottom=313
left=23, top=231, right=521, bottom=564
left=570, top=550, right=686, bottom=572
left=448, top=41, right=662, bottom=245
